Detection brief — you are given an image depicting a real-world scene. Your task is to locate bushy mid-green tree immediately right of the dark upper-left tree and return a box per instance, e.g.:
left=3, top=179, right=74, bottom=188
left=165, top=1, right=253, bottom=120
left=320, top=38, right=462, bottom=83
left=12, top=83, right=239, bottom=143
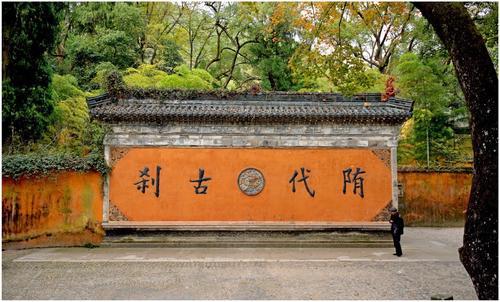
left=66, top=3, right=144, bottom=89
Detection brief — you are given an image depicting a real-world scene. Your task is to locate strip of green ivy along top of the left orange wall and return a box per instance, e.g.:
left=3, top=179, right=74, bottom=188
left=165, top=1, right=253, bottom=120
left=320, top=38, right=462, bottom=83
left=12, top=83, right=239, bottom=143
left=2, top=153, right=109, bottom=179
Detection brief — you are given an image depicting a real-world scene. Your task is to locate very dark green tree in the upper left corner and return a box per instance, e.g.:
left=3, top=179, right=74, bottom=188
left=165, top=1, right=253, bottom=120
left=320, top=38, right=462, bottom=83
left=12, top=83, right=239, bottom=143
left=2, top=2, right=63, bottom=143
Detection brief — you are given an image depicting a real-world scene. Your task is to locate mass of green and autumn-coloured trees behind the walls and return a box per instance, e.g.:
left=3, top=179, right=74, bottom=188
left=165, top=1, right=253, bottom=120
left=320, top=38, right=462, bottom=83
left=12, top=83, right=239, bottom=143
left=2, top=2, right=498, bottom=170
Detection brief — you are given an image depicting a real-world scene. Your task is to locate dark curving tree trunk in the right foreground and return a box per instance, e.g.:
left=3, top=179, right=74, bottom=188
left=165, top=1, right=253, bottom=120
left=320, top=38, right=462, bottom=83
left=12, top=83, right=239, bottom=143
left=414, top=2, right=498, bottom=300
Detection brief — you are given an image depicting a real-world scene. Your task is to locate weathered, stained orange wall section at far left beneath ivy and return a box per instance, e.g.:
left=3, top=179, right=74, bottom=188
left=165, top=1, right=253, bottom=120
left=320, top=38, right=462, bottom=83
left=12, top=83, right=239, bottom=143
left=2, top=172, right=103, bottom=246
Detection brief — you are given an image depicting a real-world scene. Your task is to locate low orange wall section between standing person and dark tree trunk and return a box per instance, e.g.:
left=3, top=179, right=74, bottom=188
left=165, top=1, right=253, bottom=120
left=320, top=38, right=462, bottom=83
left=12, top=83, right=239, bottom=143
left=398, top=172, right=472, bottom=225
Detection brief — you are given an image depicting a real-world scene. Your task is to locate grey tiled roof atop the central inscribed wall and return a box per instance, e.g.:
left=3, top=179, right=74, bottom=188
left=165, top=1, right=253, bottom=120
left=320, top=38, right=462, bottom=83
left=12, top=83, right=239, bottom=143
left=87, top=93, right=413, bottom=124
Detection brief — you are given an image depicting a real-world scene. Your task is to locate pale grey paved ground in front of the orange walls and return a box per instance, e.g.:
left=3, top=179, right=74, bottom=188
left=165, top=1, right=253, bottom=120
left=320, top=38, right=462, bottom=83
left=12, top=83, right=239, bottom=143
left=2, top=228, right=477, bottom=300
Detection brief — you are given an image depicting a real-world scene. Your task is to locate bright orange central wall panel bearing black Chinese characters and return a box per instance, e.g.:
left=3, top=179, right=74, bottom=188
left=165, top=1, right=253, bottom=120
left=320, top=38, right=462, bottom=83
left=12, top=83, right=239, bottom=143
left=110, top=148, right=392, bottom=221
